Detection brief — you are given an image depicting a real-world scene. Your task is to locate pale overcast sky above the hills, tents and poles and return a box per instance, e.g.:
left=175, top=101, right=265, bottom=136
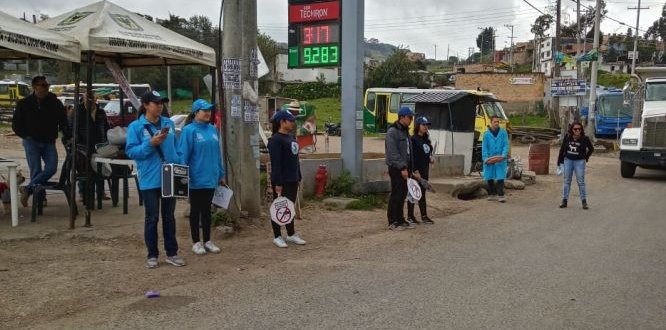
left=0, top=0, right=664, bottom=59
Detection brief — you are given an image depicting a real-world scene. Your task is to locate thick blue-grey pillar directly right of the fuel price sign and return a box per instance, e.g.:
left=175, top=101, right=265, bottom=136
left=342, top=0, right=365, bottom=180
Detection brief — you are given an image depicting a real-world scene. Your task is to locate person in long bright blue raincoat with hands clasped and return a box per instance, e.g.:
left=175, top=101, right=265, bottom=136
left=481, top=116, right=509, bottom=203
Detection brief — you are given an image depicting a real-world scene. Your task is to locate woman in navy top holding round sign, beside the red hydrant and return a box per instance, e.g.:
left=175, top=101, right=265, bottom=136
left=268, top=110, right=306, bottom=248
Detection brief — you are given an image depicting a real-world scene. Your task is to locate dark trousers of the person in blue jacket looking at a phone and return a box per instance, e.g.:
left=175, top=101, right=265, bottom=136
left=141, top=188, right=178, bottom=258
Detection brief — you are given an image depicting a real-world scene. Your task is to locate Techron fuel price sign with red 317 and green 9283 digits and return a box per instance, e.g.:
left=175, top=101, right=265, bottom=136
left=288, top=0, right=341, bottom=68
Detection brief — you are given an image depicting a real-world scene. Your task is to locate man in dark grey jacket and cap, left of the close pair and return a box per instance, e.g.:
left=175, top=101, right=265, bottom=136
left=385, top=107, right=414, bottom=230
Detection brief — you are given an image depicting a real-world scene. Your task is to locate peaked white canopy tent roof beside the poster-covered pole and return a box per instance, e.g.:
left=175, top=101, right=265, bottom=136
left=37, top=1, right=215, bottom=67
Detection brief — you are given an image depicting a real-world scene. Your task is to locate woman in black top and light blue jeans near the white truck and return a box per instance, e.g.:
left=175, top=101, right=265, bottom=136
left=557, top=122, right=594, bottom=210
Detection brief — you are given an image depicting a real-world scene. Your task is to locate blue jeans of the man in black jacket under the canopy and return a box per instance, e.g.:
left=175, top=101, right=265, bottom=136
left=23, top=139, right=58, bottom=192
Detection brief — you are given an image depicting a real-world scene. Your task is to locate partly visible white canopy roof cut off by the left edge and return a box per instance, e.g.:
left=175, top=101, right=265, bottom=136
left=0, top=12, right=81, bottom=63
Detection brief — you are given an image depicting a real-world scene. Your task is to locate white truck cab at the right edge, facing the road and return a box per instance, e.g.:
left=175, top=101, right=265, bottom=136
left=620, top=71, right=666, bottom=178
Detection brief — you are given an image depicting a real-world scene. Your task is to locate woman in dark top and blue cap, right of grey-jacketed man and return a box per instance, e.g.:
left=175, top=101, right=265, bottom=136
left=407, top=117, right=434, bottom=224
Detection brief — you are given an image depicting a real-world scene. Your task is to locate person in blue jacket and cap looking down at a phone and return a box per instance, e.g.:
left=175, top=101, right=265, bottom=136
left=125, top=91, right=185, bottom=268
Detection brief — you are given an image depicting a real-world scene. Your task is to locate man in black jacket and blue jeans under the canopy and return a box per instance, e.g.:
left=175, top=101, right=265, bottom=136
left=12, top=76, right=71, bottom=207
